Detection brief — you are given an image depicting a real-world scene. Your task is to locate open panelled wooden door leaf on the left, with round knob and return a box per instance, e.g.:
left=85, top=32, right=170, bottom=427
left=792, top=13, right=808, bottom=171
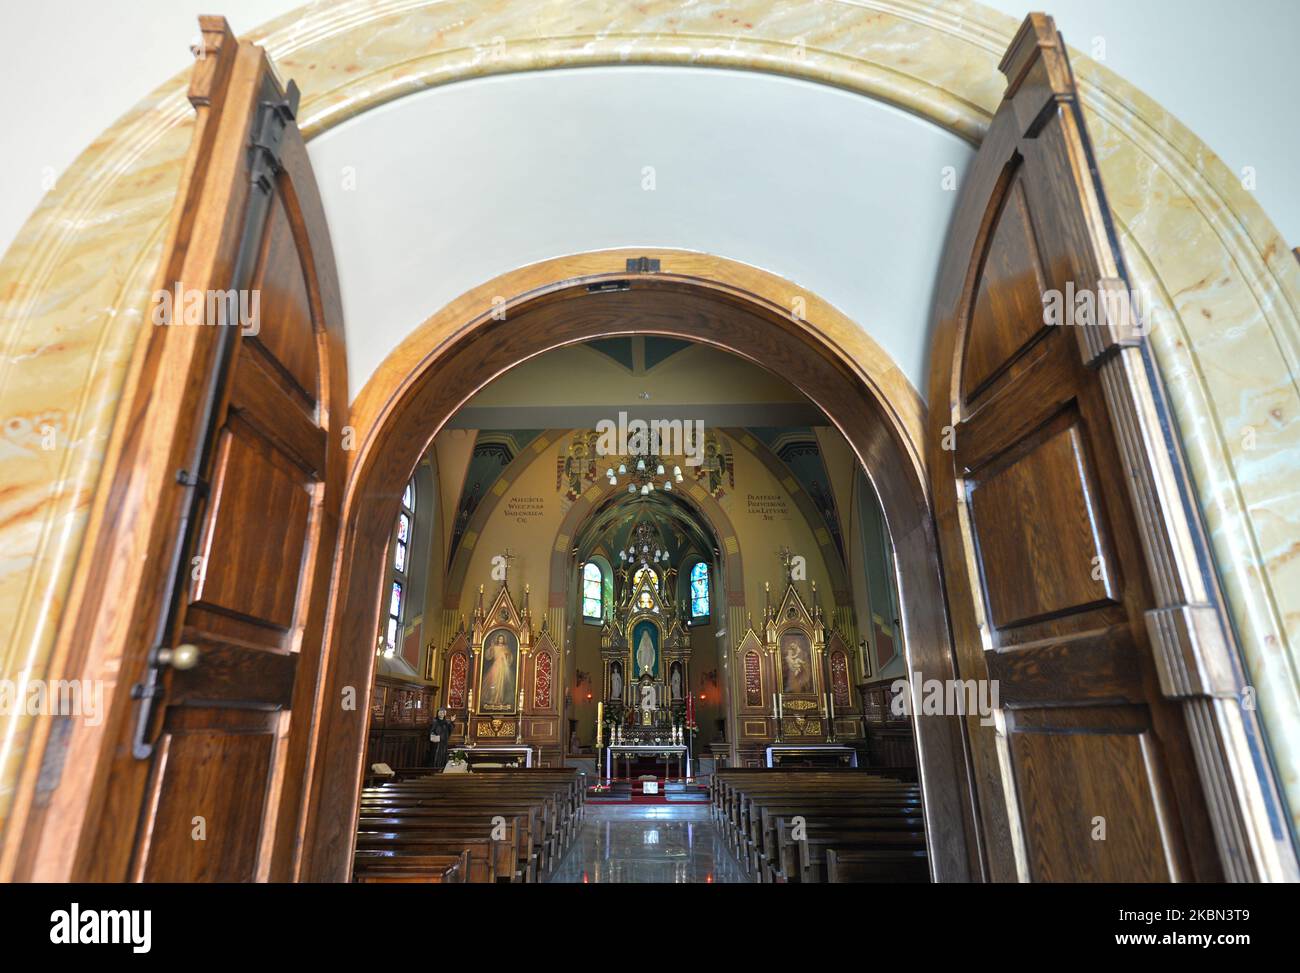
left=83, top=18, right=345, bottom=882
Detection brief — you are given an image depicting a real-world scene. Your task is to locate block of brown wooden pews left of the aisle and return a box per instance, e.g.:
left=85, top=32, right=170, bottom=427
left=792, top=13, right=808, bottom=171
left=352, top=767, right=586, bottom=883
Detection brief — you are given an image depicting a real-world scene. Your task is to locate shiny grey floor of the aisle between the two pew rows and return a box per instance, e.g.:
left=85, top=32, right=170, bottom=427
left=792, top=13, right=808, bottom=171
left=551, top=804, right=748, bottom=883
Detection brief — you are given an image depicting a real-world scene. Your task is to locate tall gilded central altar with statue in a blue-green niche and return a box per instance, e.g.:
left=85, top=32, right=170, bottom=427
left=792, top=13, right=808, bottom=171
left=597, top=563, right=693, bottom=777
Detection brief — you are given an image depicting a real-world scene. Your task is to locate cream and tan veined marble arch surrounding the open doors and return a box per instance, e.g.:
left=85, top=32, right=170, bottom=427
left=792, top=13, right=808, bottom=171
left=0, top=0, right=1300, bottom=872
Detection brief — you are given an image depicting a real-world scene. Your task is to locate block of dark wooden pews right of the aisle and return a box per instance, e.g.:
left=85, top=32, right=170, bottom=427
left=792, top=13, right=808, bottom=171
left=710, top=767, right=930, bottom=882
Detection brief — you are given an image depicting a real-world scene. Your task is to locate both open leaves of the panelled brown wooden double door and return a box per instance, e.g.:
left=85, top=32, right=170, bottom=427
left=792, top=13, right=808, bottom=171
left=35, top=18, right=1242, bottom=881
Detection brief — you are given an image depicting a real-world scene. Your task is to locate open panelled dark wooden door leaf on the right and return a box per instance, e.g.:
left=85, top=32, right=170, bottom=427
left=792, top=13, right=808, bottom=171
left=931, top=16, right=1221, bottom=881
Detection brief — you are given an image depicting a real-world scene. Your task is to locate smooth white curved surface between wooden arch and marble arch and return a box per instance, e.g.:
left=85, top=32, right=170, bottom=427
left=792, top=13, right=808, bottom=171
left=309, top=66, right=971, bottom=394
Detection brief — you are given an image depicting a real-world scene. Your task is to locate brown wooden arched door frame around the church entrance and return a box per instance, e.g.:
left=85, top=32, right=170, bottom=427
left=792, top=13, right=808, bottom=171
left=302, top=251, right=979, bottom=881
